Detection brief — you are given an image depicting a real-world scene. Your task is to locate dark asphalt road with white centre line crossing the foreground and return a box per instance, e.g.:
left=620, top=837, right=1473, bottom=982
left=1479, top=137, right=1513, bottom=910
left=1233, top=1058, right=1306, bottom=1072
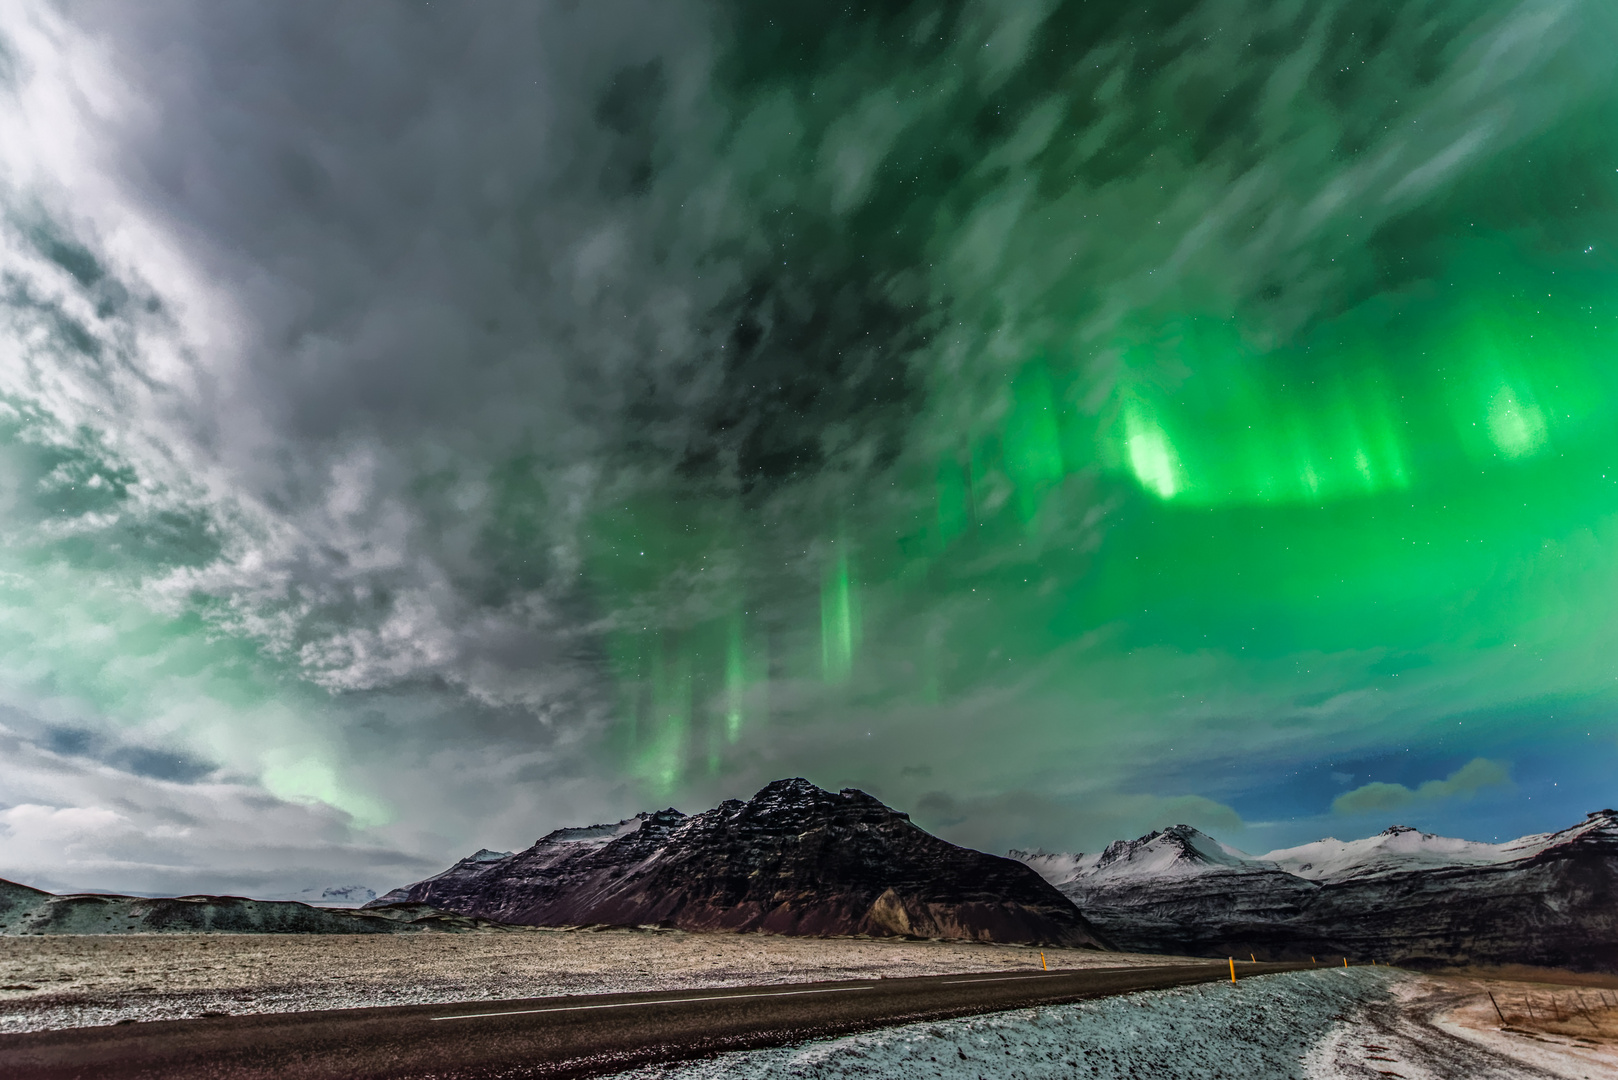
left=0, top=963, right=1307, bottom=1080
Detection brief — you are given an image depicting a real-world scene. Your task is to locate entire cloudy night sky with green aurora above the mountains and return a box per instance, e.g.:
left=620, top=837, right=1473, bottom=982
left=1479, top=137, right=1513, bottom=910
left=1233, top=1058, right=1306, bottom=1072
left=0, top=0, right=1618, bottom=895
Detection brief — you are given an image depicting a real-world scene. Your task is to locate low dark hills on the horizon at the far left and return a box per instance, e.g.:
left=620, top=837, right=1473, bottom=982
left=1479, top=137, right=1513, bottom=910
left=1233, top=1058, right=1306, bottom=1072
left=0, top=879, right=493, bottom=938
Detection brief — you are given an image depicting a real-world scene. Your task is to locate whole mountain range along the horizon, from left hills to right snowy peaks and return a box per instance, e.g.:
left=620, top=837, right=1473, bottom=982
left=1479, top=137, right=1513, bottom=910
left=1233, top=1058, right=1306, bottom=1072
left=9, top=779, right=1618, bottom=972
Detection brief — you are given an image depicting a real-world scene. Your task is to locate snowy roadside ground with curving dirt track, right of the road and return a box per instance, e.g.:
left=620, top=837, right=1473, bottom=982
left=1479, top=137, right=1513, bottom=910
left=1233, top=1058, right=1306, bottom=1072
left=618, top=967, right=1618, bottom=1080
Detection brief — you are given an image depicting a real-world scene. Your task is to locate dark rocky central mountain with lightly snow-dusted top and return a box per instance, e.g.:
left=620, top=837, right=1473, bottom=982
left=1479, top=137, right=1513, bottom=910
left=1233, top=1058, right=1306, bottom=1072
left=383, top=779, right=1103, bottom=947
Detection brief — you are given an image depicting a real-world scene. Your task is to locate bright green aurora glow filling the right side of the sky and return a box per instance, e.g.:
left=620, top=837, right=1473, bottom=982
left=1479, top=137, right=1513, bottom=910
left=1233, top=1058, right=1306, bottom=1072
left=587, top=5, right=1618, bottom=835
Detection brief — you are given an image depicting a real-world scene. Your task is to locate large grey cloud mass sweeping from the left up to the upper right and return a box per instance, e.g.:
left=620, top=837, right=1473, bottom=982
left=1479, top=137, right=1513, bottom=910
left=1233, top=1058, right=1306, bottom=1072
left=6, top=0, right=1582, bottom=880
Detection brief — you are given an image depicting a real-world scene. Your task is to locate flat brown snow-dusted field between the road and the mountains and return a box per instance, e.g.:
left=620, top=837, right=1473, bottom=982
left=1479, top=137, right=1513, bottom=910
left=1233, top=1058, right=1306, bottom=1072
left=0, top=929, right=1186, bottom=1033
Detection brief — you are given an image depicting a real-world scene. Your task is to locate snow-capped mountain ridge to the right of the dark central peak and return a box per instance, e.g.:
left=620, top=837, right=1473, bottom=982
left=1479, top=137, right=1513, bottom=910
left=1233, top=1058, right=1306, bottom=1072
left=1011, top=810, right=1618, bottom=972
